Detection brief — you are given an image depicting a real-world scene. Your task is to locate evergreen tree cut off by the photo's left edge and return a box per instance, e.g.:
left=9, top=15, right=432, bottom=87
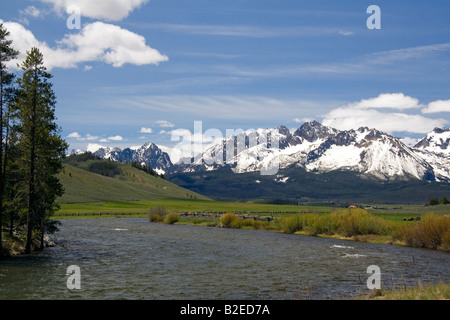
left=0, top=24, right=19, bottom=258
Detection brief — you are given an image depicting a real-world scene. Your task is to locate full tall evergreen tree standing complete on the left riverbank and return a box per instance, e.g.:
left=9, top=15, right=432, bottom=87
left=16, top=48, right=67, bottom=253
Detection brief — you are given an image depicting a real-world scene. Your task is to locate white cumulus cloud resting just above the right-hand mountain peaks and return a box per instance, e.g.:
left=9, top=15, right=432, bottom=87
left=322, top=93, right=447, bottom=133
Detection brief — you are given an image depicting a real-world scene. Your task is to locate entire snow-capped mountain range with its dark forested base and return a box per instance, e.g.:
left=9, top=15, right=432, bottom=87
left=71, top=121, right=450, bottom=204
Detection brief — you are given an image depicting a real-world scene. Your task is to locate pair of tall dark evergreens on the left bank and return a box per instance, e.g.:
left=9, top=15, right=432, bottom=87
left=0, top=24, right=68, bottom=258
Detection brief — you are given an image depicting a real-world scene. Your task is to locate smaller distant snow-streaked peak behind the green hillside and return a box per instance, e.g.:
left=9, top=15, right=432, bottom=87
left=89, top=142, right=173, bottom=174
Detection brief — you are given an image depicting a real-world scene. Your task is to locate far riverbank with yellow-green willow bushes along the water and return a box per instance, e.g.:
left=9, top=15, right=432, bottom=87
left=55, top=206, right=450, bottom=251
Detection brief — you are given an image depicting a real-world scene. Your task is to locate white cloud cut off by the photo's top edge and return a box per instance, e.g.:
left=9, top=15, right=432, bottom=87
left=40, top=0, right=148, bottom=21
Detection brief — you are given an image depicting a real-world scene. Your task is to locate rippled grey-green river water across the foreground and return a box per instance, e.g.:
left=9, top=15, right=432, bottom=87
left=0, top=218, right=450, bottom=300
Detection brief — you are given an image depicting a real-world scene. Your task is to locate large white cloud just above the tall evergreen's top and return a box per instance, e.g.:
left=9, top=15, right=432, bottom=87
left=0, top=20, right=168, bottom=69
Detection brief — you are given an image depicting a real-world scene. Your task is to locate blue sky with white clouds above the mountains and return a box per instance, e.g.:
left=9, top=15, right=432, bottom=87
left=0, top=0, right=450, bottom=158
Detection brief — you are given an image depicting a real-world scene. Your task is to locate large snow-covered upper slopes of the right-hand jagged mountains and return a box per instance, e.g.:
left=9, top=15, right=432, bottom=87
left=177, top=121, right=450, bottom=181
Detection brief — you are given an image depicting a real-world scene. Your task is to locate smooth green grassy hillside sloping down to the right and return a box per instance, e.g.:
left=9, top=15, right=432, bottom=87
left=59, top=160, right=208, bottom=204
